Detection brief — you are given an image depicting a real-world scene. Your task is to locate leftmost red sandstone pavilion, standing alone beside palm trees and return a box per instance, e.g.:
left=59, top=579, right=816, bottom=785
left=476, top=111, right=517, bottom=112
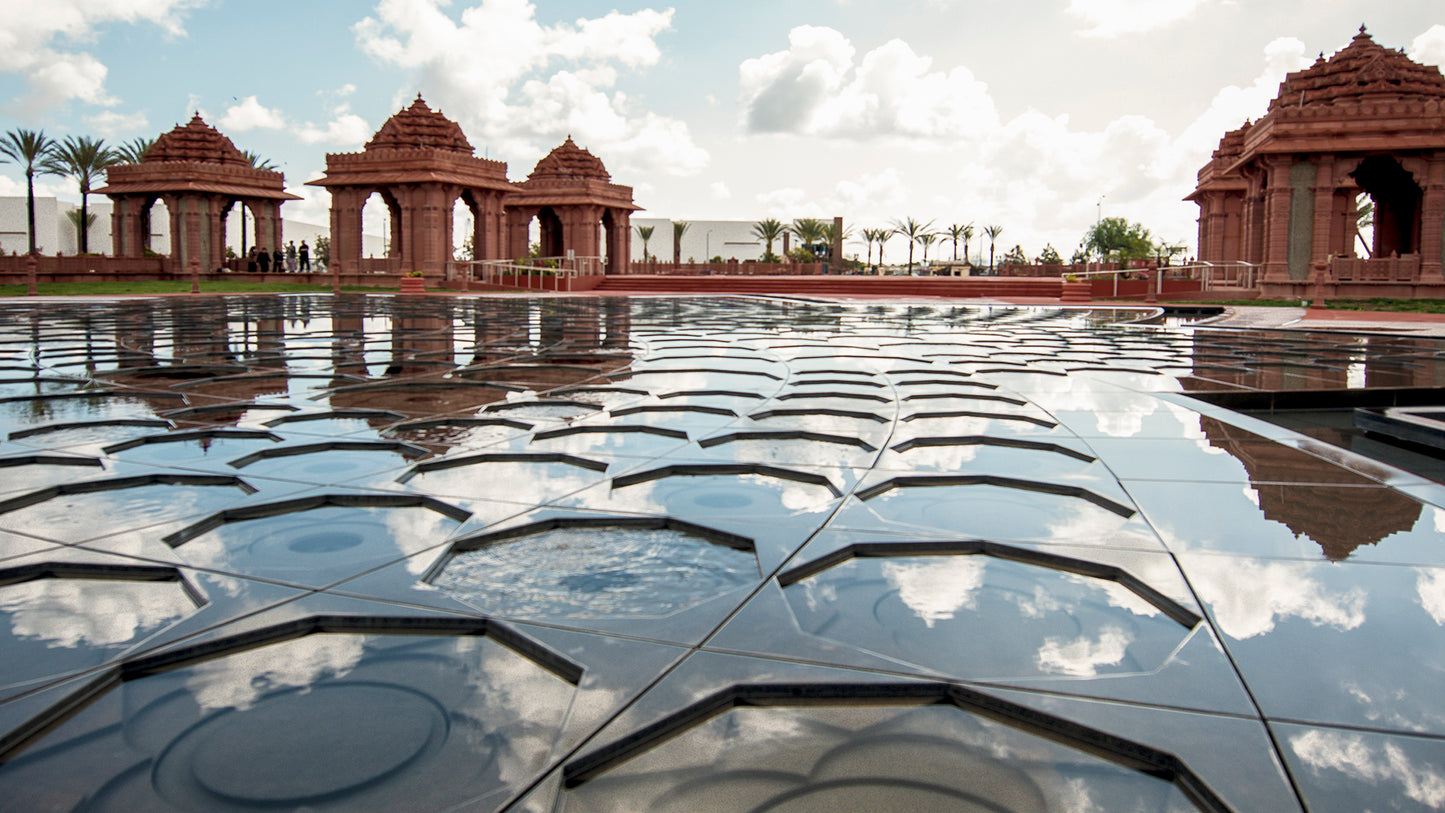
left=97, top=114, right=299, bottom=273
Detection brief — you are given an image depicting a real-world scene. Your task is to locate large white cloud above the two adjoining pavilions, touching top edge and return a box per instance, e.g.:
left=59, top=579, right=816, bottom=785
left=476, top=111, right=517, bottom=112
left=354, top=0, right=708, bottom=176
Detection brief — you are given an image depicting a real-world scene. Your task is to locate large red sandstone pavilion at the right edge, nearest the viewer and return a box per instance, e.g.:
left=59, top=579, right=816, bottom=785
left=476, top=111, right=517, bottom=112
left=1188, top=26, right=1445, bottom=297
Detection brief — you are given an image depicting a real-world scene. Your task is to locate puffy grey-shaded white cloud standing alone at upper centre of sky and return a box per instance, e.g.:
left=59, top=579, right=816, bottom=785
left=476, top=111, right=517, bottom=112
left=738, top=26, right=997, bottom=140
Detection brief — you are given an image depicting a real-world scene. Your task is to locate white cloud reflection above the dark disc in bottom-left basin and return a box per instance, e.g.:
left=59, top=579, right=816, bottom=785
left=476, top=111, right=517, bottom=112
left=185, top=634, right=364, bottom=709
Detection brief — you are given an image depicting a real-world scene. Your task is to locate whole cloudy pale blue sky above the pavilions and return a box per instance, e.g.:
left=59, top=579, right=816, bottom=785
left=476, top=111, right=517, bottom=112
left=0, top=0, right=1445, bottom=256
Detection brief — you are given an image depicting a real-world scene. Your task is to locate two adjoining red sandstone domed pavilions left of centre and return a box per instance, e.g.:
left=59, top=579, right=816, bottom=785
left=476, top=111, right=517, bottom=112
left=309, top=95, right=637, bottom=274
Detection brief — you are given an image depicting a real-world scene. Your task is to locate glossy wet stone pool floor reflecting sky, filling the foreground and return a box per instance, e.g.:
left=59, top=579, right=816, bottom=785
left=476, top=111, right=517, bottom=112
left=0, top=296, right=1445, bottom=812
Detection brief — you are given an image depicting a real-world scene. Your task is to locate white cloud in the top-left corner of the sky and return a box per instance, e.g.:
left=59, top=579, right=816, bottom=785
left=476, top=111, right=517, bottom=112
left=0, top=0, right=204, bottom=110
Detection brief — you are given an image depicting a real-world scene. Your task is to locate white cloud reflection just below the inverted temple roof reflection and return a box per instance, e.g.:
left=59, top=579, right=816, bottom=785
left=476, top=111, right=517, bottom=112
left=1189, top=556, right=1366, bottom=641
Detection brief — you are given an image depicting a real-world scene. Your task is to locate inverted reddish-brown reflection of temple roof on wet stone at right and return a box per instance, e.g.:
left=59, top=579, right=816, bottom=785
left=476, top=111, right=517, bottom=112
left=1199, top=416, right=1422, bottom=562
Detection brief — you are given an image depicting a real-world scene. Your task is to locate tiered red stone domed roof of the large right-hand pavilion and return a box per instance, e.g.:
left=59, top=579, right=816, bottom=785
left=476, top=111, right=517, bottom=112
left=1270, top=26, right=1445, bottom=111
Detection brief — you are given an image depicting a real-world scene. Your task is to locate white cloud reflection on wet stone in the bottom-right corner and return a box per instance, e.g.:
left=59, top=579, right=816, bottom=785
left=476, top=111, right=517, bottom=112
left=1289, top=729, right=1445, bottom=810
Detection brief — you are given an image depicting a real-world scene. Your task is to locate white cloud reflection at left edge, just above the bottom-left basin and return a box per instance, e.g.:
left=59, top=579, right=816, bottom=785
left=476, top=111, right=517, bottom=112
left=0, top=579, right=195, bottom=647
